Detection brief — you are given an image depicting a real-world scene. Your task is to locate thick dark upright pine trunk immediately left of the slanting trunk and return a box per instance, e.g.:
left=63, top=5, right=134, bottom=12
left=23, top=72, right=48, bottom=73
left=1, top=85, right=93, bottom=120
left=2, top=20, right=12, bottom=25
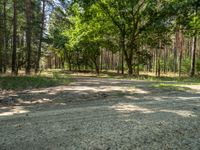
left=25, top=0, right=32, bottom=75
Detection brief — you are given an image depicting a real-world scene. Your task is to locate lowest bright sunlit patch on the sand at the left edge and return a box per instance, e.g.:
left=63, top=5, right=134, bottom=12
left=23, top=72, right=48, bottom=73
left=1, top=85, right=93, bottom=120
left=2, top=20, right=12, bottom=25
left=0, top=106, right=30, bottom=117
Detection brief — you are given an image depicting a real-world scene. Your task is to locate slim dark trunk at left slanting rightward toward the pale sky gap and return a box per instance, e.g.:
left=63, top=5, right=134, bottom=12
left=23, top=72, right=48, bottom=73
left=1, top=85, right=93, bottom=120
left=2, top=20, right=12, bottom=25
left=35, top=0, right=45, bottom=73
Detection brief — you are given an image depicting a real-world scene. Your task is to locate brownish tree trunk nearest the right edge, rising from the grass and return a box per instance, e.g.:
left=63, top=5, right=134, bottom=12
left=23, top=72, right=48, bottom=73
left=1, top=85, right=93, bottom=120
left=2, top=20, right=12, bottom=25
left=190, top=36, right=197, bottom=77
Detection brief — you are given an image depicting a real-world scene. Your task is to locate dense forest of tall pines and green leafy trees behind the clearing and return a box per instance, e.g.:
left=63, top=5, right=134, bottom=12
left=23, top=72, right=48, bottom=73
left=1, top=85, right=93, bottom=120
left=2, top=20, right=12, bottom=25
left=0, top=0, right=200, bottom=77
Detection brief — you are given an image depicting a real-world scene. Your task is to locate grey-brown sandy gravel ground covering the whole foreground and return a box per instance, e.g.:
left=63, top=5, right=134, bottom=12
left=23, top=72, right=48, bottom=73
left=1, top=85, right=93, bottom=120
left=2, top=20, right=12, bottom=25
left=0, top=78, right=200, bottom=150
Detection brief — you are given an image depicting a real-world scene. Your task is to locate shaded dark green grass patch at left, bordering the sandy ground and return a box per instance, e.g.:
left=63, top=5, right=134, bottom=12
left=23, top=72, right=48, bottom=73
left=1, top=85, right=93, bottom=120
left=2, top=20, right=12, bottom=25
left=0, top=73, right=70, bottom=91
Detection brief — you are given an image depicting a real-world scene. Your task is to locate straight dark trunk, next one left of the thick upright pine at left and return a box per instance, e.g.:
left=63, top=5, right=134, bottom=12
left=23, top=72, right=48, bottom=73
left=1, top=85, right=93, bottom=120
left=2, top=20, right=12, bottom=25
left=12, top=0, right=17, bottom=75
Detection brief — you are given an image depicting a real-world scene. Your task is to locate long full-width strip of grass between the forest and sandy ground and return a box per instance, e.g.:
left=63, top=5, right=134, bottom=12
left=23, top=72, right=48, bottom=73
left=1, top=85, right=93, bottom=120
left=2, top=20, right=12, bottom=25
left=0, top=70, right=200, bottom=90
